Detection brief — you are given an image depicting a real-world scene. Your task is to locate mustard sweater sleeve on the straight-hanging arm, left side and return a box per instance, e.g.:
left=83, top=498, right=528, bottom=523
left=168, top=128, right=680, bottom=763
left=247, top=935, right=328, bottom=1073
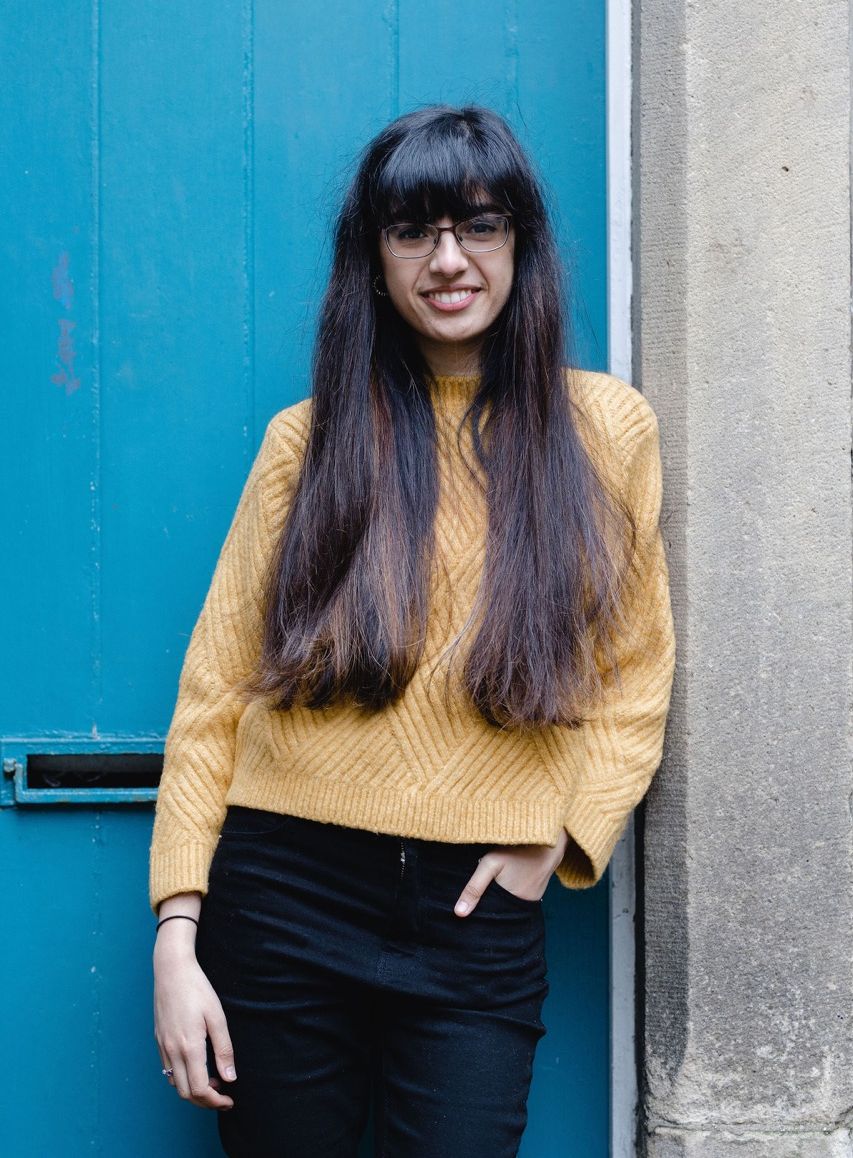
left=149, top=416, right=299, bottom=913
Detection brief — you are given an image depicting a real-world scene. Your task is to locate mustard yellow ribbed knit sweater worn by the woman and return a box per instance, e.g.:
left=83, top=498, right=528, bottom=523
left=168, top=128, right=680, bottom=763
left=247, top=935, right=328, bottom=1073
left=149, top=372, right=675, bottom=910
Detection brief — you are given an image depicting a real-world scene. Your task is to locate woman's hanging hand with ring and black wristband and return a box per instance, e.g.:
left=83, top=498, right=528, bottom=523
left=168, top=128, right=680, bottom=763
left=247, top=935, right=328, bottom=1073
left=154, top=909, right=237, bottom=1109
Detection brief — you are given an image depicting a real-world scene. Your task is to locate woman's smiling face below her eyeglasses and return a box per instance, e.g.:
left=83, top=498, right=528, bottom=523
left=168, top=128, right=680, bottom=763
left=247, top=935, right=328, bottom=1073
left=380, top=206, right=515, bottom=374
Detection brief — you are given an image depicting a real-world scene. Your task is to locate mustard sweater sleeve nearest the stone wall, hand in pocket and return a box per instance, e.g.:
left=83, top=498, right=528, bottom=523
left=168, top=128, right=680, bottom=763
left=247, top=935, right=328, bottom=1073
left=557, top=396, right=675, bottom=888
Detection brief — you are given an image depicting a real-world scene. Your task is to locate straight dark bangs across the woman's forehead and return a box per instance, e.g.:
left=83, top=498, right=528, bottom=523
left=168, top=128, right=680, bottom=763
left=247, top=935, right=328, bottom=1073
left=369, top=125, right=514, bottom=228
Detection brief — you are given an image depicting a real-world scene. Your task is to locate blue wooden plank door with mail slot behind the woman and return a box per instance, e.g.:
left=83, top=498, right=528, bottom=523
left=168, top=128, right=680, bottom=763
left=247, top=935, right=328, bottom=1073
left=0, top=0, right=609, bottom=1158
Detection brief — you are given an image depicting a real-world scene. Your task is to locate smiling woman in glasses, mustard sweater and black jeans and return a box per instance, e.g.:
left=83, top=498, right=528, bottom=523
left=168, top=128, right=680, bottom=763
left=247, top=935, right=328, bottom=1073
left=150, top=107, right=674, bottom=1158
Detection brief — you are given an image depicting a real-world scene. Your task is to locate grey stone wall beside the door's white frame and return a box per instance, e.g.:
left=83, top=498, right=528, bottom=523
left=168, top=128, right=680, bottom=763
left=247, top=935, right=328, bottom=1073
left=633, top=0, right=853, bottom=1158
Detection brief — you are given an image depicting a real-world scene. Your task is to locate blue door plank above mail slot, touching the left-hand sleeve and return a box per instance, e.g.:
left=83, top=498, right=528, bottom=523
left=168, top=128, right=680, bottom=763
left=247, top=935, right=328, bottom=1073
left=98, top=0, right=249, bottom=733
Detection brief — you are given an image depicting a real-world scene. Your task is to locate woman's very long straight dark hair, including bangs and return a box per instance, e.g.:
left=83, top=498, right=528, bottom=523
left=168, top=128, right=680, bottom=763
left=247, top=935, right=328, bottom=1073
left=238, top=105, right=634, bottom=728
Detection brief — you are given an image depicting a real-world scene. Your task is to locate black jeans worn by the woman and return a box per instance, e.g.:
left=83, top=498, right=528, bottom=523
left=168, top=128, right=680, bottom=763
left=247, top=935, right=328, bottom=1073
left=197, top=806, right=549, bottom=1158
